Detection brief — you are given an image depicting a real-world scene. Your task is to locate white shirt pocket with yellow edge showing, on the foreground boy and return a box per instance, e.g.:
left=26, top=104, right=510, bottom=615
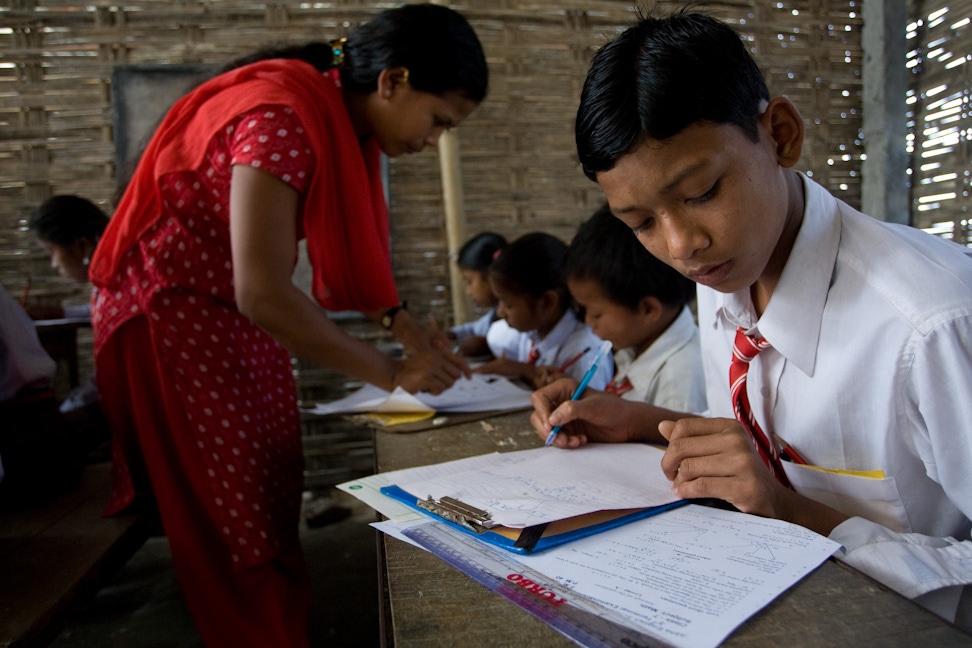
left=782, top=461, right=911, bottom=533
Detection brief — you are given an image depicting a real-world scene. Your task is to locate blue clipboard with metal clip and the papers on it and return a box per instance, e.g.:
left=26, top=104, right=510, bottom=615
left=339, top=444, right=684, bottom=553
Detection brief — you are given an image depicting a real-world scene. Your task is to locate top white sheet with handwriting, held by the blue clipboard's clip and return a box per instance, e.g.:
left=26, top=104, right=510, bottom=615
left=393, top=443, right=679, bottom=528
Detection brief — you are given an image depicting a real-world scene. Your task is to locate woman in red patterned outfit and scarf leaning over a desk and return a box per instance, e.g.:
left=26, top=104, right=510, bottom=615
left=91, top=5, right=487, bottom=648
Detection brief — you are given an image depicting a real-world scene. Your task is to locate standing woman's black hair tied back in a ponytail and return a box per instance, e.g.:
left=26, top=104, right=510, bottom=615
left=217, top=4, right=489, bottom=104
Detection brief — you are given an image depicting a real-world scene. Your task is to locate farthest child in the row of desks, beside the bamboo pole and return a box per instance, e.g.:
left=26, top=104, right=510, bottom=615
left=449, top=232, right=506, bottom=357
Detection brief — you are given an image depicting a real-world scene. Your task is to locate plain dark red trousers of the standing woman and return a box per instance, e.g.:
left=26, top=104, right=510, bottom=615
left=97, top=316, right=310, bottom=648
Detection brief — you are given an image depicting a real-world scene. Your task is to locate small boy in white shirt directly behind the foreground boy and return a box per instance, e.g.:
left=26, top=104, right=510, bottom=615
left=564, top=205, right=705, bottom=413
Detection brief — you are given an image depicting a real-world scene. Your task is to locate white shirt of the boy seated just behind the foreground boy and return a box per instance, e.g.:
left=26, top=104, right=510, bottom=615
left=607, top=306, right=705, bottom=413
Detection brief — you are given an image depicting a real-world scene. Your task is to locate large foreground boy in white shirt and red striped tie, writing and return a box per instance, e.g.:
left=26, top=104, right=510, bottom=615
left=532, top=11, right=972, bottom=629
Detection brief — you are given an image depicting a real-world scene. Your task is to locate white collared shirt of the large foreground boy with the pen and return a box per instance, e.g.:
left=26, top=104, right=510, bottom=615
left=698, top=177, right=972, bottom=627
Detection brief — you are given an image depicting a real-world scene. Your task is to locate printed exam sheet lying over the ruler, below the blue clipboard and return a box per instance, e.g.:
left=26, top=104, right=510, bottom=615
left=373, top=504, right=839, bottom=648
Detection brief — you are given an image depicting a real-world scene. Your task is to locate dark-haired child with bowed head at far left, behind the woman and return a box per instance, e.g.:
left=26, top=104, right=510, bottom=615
left=24, top=195, right=108, bottom=319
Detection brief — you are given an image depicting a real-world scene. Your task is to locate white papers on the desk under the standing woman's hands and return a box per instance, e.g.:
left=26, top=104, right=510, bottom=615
left=307, top=374, right=530, bottom=414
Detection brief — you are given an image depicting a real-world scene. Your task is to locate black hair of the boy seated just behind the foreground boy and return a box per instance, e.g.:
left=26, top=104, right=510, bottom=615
left=564, top=205, right=695, bottom=310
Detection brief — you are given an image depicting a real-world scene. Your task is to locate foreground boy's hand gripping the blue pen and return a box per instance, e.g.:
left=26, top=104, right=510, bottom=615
left=530, top=378, right=644, bottom=448
